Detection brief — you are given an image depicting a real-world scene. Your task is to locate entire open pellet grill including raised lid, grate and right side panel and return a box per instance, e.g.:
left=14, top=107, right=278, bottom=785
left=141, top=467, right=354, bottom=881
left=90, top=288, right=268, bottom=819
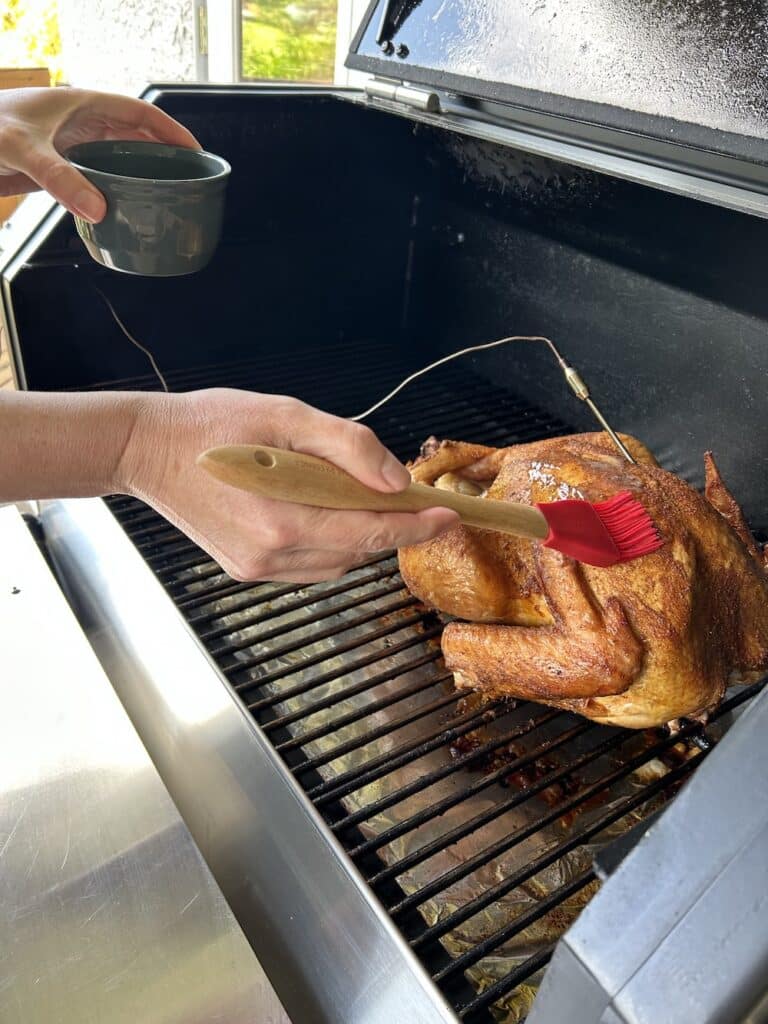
left=3, top=0, right=768, bottom=1024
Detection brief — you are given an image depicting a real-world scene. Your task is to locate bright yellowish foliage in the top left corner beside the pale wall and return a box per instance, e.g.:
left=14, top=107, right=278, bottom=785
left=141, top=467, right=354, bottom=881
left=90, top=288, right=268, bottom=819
left=0, top=0, right=61, bottom=84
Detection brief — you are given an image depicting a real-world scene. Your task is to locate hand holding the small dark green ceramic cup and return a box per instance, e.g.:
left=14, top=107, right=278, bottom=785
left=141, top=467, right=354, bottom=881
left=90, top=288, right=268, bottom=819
left=0, top=88, right=200, bottom=224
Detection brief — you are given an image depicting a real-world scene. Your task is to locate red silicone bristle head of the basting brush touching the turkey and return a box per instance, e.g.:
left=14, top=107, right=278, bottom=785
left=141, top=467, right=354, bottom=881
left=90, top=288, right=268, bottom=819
left=537, top=490, right=664, bottom=567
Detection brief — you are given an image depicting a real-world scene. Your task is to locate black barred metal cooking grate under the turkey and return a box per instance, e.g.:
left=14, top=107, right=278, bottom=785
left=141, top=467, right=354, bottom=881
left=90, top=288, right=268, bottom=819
left=100, top=348, right=757, bottom=1024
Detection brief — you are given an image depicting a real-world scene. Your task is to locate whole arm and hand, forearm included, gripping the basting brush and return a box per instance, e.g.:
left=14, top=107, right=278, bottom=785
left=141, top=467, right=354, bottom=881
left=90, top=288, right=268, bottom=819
left=0, top=388, right=458, bottom=583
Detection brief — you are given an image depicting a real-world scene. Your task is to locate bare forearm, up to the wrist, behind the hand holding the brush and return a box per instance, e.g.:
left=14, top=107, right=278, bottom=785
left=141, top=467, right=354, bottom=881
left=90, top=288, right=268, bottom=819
left=0, top=391, right=157, bottom=502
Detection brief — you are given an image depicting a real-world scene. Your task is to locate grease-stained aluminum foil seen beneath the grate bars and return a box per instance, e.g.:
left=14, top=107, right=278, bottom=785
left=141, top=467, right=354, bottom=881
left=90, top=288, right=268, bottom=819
left=193, top=559, right=696, bottom=1024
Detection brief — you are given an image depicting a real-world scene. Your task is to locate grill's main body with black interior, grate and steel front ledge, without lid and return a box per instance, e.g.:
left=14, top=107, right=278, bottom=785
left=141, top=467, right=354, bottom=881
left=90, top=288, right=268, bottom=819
left=3, top=81, right=768, bottom=1024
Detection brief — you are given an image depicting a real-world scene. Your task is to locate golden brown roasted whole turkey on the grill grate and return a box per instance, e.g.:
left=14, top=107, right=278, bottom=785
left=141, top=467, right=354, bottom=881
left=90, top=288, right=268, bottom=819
left=399, top=434, right=768, bottom=728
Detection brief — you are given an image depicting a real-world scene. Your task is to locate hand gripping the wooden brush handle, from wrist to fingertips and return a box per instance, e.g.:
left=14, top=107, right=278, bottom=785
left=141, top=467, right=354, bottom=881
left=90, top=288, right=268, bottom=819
left=118, top=388, right=459, bottom=583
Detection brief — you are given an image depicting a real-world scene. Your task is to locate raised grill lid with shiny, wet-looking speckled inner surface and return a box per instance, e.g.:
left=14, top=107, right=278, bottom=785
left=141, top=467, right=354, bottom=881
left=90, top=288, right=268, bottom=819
left=347, top=0, right=768, bottom=190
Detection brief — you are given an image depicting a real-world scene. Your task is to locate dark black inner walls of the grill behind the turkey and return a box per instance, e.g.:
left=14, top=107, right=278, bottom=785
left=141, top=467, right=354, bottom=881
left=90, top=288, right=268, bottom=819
left=10, top=87, right=768, bottom=529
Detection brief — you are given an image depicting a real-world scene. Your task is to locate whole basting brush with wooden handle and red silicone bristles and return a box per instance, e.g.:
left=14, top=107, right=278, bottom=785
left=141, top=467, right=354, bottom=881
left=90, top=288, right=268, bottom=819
left=198, top=444, right=664, bottom=567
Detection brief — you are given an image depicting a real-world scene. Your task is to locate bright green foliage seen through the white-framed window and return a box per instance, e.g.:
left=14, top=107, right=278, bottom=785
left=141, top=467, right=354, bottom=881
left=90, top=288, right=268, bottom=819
left=242, top=0, right=336, bottom=82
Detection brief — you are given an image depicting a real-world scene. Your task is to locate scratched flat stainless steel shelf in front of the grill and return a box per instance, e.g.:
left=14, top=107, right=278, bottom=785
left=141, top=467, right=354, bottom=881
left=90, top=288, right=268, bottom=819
left=0, top=507, right=290, bottom=1024
